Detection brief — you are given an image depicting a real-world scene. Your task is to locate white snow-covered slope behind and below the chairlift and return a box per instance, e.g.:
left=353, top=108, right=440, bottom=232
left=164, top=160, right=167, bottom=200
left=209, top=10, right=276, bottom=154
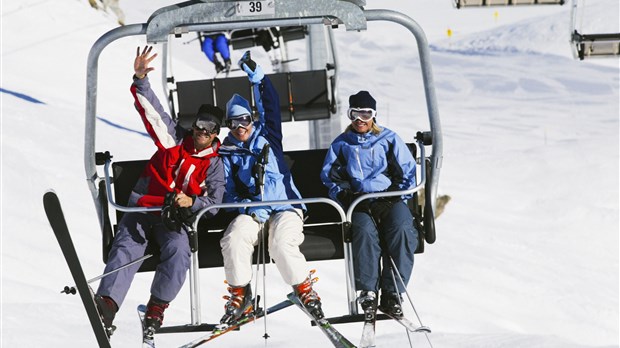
left=0, top=0, right=620, bottom=348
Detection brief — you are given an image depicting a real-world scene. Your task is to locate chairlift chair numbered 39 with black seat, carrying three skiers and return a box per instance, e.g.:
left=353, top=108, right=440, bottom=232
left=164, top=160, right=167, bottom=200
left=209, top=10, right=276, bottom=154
left=84, top=0, right=443, bottom=338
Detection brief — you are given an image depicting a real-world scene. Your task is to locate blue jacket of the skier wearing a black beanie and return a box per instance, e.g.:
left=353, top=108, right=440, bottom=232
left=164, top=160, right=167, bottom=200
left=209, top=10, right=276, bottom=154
left=321, top=127, right=416, bottom=203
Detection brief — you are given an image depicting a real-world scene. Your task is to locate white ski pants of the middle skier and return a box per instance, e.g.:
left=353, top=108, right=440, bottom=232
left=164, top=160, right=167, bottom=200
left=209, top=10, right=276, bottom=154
left=220, top=209, right=309, bottom=286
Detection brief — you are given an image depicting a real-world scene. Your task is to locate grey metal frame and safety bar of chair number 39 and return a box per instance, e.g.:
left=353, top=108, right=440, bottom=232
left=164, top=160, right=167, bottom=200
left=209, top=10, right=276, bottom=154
left=84, top=0, right=443, bottom=331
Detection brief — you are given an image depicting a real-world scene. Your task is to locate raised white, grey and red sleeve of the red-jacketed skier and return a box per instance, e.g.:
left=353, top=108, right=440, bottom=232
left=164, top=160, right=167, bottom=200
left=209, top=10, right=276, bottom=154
left=131, top=77, right=183, bottom=150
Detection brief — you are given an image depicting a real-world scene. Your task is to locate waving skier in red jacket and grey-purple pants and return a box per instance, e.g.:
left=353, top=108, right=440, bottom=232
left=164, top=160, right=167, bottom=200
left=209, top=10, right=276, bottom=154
left=95, top=47, right=225, bottom=335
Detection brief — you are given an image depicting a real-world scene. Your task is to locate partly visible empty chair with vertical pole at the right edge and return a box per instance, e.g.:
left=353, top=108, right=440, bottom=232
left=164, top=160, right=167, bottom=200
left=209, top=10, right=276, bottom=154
left=570, top=0, right=620, bottom=60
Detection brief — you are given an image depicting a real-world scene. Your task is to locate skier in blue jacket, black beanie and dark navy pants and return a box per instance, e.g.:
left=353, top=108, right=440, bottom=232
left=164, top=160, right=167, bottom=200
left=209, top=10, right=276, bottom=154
left=321, top=91, right=418, bottom=316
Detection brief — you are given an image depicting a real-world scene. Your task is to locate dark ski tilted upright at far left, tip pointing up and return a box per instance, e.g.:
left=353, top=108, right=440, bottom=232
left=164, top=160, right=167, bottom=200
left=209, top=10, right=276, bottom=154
left=43, top=191, right=111, bottom=348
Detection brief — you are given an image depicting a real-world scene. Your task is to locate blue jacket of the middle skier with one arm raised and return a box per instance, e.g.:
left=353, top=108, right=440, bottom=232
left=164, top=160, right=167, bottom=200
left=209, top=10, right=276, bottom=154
left=219, top=76, right=305, bottom=213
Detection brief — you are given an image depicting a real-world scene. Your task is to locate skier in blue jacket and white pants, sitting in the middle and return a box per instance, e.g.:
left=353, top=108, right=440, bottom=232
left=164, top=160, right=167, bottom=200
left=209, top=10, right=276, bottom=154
left=219, top=51, right=324, bottom=324
